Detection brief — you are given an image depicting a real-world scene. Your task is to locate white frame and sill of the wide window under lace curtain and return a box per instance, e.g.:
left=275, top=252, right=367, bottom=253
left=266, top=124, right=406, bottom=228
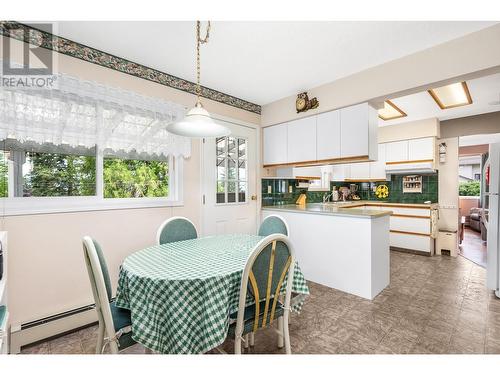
left=0, top=146, right=184, bottom=216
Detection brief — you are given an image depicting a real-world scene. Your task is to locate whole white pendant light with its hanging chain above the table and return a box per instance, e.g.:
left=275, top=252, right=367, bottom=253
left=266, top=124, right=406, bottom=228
left=167, top=21, right=231, bottom=138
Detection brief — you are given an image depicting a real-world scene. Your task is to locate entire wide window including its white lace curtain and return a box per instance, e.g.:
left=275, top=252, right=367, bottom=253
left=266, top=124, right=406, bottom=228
left=0, top=75, right=191, bottom=215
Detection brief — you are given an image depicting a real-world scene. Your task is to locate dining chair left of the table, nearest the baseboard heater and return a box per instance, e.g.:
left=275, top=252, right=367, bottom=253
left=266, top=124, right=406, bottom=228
left=83, top=236, right=135, bottom=354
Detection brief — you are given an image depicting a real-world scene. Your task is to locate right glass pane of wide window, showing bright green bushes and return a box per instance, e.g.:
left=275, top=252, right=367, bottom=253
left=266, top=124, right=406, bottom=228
left=104, top=158, right=169, bottom=198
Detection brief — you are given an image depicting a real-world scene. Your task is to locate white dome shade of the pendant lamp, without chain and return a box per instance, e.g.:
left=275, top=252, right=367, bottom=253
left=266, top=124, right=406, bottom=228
left=167, top=103, right=231, bottom=138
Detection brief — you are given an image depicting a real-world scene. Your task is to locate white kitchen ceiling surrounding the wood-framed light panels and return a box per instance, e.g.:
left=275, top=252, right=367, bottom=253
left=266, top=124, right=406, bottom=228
left=379, top=74, right=500, bottom=126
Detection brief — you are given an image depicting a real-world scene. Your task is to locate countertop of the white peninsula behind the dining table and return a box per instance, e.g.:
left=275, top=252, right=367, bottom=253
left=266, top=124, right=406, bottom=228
left=262, top=202, right=392, bottom=219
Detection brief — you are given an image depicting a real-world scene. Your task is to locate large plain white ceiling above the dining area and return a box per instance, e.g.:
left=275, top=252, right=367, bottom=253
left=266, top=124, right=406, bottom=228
left=54, top=21, right=494, bottom=105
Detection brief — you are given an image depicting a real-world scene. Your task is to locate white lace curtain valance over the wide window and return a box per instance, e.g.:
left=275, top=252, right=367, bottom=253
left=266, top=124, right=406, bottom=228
left=0, top=67, right=191, bottom=158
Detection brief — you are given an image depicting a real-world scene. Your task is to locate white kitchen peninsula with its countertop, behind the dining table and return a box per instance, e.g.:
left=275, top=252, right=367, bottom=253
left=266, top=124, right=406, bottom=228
left=262, top=203, right=391, bottom=299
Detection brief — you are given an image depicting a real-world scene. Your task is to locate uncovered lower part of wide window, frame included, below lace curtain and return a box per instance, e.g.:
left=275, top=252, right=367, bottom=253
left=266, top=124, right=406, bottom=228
left=0, top=139, right=183, bottom=214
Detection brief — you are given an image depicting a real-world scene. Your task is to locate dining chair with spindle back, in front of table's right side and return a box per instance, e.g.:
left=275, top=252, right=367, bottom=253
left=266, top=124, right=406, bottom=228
left=229, top=234, right=295, bottom=354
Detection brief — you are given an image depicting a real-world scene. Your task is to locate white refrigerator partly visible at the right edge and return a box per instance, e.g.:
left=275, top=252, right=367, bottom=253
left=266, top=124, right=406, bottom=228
left=483, top=143, right=500, bottom=298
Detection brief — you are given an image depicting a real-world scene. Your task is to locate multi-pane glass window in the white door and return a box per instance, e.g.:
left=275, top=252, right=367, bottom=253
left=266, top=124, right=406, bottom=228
left=215, top=137, right=247, bottom=203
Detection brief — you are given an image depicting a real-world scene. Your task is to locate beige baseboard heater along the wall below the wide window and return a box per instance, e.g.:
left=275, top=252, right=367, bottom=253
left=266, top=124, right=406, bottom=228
left=10, top=304, right=97, bottom=354
